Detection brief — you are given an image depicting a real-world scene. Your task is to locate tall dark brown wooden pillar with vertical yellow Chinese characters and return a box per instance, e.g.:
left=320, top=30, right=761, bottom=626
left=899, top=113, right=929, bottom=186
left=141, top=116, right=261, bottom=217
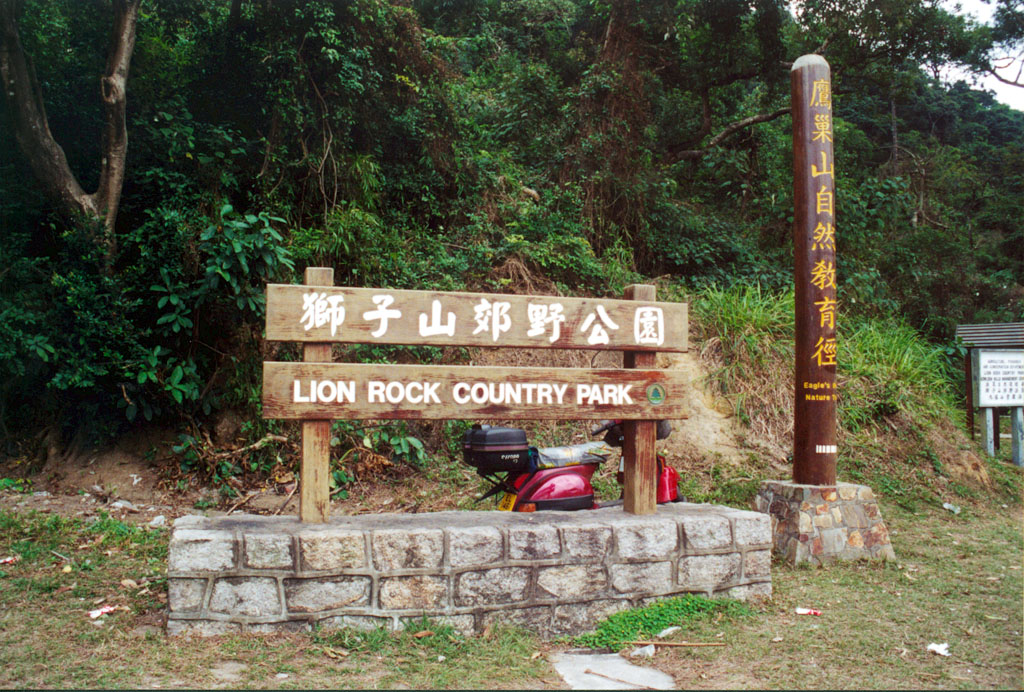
left=790, top=55, right=839, bottom=485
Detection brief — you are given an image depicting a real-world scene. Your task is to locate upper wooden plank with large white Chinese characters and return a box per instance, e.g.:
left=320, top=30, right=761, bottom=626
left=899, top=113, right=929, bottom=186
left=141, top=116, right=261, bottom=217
left=266, top=284, right=687, bottom=351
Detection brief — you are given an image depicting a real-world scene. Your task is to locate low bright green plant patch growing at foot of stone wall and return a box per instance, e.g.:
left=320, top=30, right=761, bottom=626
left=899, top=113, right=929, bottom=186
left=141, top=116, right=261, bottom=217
left=574, top=594, right=753, bottom=649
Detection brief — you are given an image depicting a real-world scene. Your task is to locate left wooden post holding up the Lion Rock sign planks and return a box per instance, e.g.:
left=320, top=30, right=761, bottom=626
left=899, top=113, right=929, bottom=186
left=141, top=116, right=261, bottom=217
left=299, top=267, right=334, bottom=523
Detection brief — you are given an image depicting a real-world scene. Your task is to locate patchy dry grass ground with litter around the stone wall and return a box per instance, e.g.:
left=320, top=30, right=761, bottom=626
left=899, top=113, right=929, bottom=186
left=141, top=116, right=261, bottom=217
left=0, top=494, right=1024, bottom=689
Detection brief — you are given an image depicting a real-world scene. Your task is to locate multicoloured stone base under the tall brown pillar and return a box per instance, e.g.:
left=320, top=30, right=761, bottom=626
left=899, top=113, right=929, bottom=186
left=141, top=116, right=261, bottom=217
left=755, top=480, right=896, bottom=565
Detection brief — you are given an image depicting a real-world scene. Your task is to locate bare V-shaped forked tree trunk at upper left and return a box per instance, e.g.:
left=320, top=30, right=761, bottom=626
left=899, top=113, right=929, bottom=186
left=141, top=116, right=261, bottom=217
left=0, top=0, right=141, bottom=270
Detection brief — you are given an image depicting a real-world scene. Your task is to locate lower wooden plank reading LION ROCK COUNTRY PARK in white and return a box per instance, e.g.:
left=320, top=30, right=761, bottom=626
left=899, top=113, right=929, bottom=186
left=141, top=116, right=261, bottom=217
left=263, top=362, right=688, bottom=420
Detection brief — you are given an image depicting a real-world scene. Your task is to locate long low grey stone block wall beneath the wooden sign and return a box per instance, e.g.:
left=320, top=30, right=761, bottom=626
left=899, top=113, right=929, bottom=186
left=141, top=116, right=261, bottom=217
left=167, top=503, right=771, bottom=637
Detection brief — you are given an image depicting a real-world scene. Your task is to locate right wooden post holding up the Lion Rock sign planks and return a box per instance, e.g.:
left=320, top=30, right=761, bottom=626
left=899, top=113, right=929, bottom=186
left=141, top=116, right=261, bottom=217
left=623, top=284, right=657, bottom=514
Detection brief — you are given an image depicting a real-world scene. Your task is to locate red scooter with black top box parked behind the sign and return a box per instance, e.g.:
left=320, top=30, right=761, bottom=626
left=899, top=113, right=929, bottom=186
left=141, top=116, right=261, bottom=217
left=462, top=421, right=679, bottom=512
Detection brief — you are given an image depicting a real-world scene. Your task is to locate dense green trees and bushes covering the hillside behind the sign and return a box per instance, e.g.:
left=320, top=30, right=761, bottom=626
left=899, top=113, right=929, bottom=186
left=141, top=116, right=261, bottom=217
left=0, top=0, right=1024, bottom=470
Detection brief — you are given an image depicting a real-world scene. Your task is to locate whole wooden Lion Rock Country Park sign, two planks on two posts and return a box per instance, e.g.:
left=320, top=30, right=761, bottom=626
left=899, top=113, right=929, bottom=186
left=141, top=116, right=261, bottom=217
left=263, top=276, right=687, bottom=522
